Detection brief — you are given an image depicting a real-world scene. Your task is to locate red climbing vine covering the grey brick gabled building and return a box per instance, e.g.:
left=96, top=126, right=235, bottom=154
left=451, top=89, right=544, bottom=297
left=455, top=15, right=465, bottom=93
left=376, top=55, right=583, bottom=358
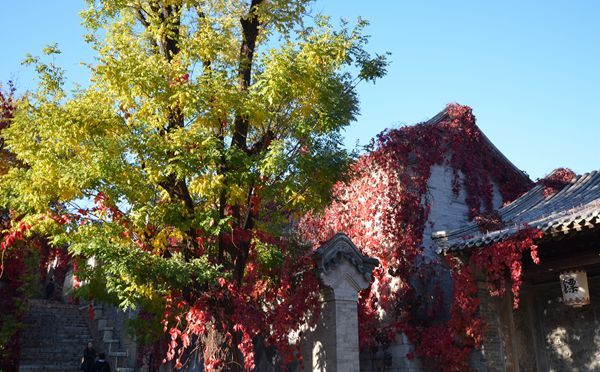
left=299, top=104, right=531, bottom=371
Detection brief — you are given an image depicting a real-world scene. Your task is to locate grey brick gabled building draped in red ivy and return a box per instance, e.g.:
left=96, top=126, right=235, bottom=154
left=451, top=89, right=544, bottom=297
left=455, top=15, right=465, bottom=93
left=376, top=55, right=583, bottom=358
left=308, top=104, right=534, bottom=372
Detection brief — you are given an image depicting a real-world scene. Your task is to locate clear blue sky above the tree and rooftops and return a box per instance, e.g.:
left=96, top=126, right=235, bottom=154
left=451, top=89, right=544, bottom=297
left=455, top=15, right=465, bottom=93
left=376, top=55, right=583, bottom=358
left=0, top=0, right=600, bottom=179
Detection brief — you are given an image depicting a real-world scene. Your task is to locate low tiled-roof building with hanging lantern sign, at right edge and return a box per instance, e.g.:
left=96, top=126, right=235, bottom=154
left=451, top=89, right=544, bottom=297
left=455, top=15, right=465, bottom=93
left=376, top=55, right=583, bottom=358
left=434, top=170, right=600, bottom=371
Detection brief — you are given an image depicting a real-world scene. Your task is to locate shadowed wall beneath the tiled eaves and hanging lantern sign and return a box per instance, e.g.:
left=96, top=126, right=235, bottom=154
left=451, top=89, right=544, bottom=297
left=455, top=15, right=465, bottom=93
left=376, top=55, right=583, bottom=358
left=478, top=266, right=600, bottom=372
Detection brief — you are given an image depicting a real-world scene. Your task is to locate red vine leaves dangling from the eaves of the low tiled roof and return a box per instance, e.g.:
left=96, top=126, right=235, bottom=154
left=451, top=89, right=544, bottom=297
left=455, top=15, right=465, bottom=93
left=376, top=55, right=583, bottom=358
left=471, top=227, right=543, bottom=309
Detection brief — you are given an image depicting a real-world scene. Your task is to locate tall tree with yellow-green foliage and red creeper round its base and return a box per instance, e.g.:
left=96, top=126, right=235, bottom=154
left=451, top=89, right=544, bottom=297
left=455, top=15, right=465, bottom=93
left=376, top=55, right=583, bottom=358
left=0, top=0, right=387, bottom=370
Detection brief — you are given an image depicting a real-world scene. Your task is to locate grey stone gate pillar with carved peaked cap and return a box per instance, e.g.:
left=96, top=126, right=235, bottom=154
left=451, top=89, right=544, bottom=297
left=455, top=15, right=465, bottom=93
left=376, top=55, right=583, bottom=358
left=304, top=234, right=379, bottom=372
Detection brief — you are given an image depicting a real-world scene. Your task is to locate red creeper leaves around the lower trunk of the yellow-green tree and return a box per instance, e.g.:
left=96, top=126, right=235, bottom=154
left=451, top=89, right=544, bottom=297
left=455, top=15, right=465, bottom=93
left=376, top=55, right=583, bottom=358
left=158, top=231, right=320, bottom=371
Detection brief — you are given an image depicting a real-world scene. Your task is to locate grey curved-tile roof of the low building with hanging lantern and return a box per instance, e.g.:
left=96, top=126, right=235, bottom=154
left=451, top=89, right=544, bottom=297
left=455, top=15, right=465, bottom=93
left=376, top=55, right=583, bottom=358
left=432, top=171, right=600, bottom=251
